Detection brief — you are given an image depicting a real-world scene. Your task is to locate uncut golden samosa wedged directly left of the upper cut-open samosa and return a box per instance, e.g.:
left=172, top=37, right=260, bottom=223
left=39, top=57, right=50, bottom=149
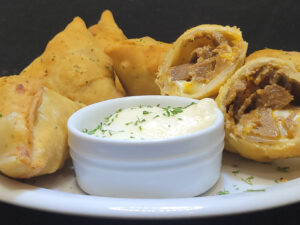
left=105, top=37, right=172, bottom=95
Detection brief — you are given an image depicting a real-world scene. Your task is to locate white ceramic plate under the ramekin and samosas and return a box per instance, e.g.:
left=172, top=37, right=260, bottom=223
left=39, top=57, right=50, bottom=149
left=0, top=153, right=300, bottom=218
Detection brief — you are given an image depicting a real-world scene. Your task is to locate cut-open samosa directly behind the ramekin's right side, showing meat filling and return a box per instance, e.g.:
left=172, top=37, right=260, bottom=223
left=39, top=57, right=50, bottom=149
left=156, top=25, right=248, bottom=99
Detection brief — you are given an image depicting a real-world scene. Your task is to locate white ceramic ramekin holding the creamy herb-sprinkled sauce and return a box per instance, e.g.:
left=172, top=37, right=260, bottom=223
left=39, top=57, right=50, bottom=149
left=68, top=96, right=224, bottom=198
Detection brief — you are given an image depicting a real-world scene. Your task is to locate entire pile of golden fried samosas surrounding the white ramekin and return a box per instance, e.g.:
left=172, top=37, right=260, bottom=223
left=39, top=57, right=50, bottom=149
left=0, top=10, right=300, bottom=178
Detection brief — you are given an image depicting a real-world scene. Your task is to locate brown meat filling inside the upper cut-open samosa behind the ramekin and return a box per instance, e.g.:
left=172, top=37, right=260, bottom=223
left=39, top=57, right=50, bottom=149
left=169, top=33, right=231, bottom=83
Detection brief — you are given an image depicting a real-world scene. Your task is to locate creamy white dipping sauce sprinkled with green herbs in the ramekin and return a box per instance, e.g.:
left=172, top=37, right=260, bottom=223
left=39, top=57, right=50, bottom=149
left=83, top=98, right=218, bottom=140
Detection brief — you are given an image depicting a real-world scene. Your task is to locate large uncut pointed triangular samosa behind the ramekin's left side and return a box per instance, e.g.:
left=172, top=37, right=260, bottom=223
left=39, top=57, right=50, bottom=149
left=20, top=17, right=123, bottom=104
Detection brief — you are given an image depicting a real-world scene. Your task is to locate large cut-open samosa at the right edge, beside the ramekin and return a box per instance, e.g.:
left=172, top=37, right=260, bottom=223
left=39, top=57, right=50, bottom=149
left=216, top=57, right=300, bottom=161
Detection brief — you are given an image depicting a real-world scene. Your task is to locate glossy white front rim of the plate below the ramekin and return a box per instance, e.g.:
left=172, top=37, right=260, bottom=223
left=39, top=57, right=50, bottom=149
left=0, top=175, right=300, bottom=219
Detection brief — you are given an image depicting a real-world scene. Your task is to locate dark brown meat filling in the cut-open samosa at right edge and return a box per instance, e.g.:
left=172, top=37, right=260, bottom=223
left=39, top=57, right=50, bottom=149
left=227, top=66, right=299, bottom=140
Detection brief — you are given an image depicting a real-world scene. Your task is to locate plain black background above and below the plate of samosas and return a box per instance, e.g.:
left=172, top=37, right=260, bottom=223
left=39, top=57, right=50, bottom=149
left=0, top=0, right=300, bottom=225
